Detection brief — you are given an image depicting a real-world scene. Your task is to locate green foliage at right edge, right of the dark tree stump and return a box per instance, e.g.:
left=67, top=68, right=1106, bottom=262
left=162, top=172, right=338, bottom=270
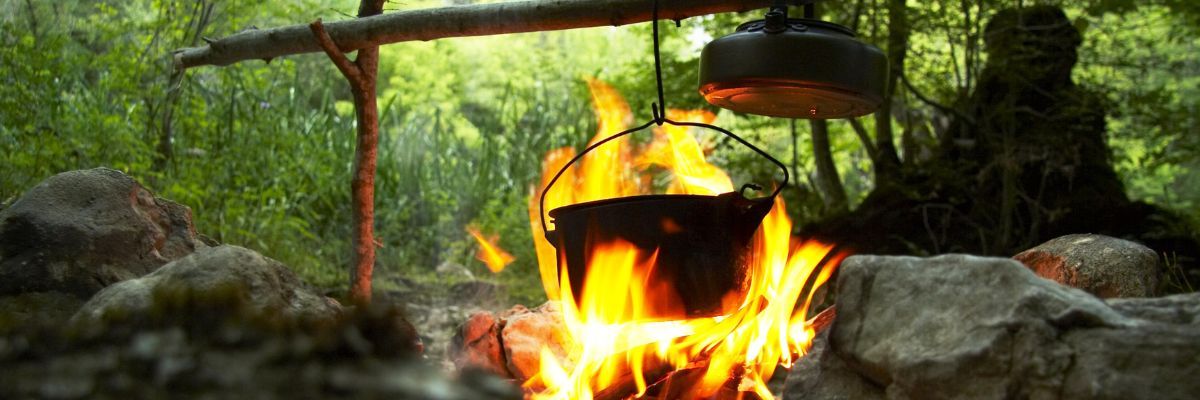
left=1076, top=7, right=1200, bottom=217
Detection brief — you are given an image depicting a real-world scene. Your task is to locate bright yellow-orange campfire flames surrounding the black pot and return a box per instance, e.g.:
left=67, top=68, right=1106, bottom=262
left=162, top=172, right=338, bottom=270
left=524, top=80, right=842, bottom=399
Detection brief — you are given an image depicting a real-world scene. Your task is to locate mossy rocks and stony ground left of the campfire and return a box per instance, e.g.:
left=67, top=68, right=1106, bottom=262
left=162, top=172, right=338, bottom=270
left=0, top=168, right=521, bottom=399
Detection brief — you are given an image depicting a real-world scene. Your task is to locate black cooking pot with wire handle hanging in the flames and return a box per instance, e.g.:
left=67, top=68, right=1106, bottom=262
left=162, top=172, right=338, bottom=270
left=541, top=119, right=787, bottom=322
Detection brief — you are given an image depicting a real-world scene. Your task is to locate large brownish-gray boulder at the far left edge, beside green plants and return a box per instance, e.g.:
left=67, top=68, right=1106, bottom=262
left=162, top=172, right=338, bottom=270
left=0, top=168, right=204, bottom=299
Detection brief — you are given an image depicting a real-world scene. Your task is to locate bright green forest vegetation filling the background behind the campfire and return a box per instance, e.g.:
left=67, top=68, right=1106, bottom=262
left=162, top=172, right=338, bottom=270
left=0, top=0, right=1200, bottom=303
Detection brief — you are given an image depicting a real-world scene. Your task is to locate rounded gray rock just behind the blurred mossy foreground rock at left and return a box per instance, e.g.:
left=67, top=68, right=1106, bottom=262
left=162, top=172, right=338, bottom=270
left=74, top=245, right=341, bottom=320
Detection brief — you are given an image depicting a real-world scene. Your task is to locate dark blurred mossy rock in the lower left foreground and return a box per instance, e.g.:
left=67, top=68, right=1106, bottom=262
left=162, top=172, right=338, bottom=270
left=0, top=308, right=511, bottom=400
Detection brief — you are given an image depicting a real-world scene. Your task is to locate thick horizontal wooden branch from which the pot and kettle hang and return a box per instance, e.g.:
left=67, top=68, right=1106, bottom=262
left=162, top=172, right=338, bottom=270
left=174, top=0, right=817, bottom=70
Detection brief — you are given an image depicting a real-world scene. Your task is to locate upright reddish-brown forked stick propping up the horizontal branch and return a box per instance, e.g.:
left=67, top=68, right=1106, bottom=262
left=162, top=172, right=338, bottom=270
left=308, top=0, right=384, bottom=305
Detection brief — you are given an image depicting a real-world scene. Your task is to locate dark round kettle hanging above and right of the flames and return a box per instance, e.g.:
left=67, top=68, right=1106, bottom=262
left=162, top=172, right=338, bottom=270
left=700, top=8, right=888, bottom=119
